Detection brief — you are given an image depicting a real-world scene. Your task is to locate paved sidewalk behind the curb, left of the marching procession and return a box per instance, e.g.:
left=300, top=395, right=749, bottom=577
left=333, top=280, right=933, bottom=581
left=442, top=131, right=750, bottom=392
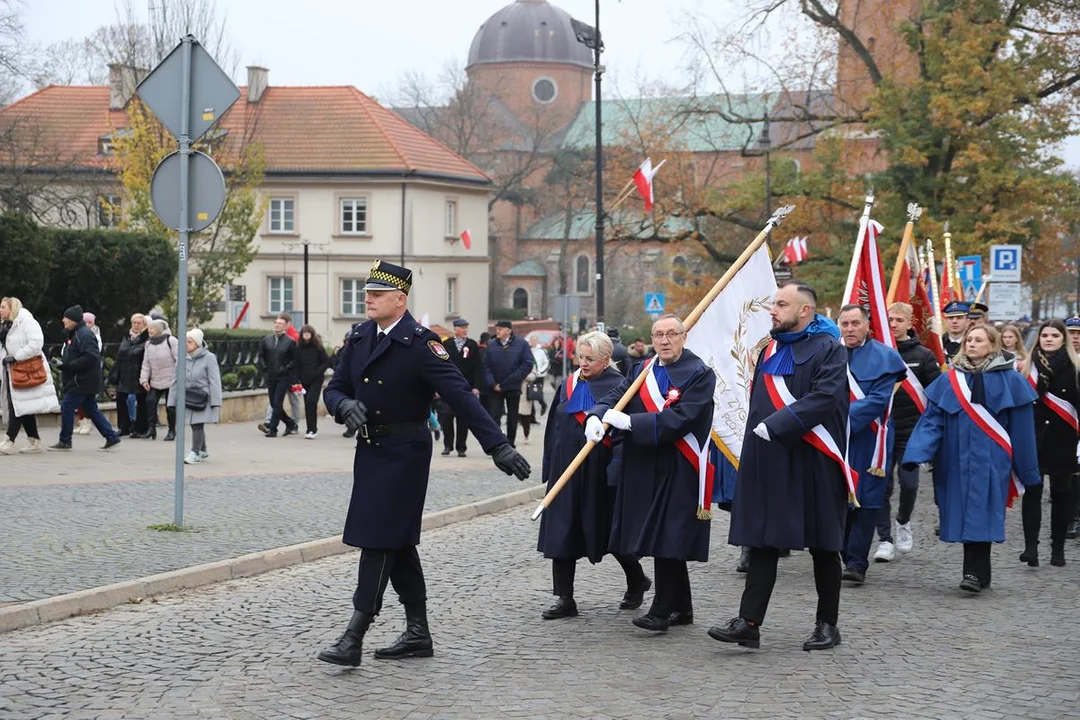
left=0, top=425, right=540, bottom=604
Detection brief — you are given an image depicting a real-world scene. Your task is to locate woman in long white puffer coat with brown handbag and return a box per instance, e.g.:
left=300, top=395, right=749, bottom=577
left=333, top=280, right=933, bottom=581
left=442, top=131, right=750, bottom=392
left=0, top=298, right=60, bottom=454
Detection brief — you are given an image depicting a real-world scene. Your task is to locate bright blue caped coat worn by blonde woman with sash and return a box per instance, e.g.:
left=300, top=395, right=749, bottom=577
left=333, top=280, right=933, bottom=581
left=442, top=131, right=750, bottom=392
left=903, top=363, right=1042, bottom=543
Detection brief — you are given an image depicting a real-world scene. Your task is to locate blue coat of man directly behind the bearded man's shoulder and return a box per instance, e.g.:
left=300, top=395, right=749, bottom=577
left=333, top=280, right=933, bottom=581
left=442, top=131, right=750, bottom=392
left=848, top=339, right=907, bottom=510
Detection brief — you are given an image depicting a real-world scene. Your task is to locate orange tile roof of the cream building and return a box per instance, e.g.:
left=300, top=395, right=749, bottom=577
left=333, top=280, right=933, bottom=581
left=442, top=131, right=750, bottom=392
left=0, top=85, right=490, bottom=184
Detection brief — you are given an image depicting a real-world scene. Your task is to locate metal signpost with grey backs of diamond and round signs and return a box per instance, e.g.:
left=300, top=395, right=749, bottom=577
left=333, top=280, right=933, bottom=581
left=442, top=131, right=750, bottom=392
left=135, top=35, right=240, bottom=526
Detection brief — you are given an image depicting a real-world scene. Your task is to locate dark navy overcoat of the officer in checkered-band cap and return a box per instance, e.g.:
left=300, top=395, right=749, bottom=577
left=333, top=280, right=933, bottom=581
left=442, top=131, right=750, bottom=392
left=323, top=312, right=507, bottom=549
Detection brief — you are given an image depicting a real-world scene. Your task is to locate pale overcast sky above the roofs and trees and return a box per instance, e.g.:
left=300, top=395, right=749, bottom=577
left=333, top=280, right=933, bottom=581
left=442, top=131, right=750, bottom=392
left=26, top=0, right=1080, bottom=168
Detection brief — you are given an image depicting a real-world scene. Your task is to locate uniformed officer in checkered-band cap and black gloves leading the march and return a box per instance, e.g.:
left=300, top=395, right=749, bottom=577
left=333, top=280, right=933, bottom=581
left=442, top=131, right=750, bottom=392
left=319, top=261, right=529, bottom=666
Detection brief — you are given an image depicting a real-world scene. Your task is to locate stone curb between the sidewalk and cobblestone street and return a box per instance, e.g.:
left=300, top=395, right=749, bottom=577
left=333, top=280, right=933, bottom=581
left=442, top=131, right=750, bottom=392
left=0, top=485, right=546, bottom=633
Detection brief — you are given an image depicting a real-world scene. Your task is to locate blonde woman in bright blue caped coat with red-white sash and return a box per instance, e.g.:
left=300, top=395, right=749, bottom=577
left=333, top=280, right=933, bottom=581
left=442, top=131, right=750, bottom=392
left=903, top=325, right=1042, bottom=593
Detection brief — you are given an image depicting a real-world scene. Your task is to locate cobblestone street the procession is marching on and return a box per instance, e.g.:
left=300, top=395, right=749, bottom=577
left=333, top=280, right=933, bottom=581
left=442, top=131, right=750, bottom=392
left=0, top=499, right=1080, bottom=720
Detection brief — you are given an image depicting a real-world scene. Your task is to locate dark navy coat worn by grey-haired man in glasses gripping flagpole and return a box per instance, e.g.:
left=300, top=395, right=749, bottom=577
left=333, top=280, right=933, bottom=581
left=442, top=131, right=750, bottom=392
left=590, top=350, right=716, bottom=562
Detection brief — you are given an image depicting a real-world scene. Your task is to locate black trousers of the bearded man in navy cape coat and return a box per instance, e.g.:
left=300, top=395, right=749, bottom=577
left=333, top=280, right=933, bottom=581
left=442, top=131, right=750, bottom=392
left=739, top=547, right=840, bottom=625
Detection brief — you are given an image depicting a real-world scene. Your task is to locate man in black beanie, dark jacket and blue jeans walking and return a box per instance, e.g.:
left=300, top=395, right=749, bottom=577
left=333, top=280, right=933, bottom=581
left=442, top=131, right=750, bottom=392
left=49, top=305, right=120, bottom=450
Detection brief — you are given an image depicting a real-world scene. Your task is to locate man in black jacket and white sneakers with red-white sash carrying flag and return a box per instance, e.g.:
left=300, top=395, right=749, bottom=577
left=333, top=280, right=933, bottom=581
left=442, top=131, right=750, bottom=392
left=874, top=302, right=942, bottom=562
